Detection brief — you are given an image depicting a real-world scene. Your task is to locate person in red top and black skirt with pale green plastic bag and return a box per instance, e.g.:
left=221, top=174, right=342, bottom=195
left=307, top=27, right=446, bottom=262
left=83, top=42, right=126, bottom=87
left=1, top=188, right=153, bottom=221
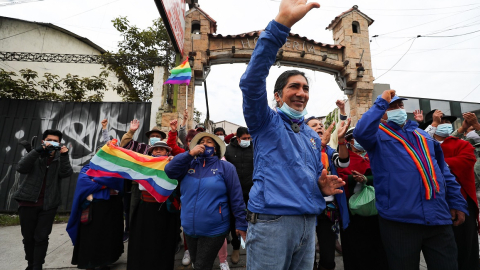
left=338, top=128, right=388, bottom=270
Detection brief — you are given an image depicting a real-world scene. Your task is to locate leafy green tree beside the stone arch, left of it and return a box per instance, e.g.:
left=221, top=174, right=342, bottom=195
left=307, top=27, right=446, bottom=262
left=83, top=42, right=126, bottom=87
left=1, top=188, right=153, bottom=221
left=104, top=17, right=175, bottom=101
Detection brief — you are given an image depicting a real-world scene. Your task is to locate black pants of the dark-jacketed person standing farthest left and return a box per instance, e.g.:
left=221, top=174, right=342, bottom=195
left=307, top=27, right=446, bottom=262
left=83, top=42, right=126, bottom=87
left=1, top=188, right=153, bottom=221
left=18, top=206, right=57, bottom=269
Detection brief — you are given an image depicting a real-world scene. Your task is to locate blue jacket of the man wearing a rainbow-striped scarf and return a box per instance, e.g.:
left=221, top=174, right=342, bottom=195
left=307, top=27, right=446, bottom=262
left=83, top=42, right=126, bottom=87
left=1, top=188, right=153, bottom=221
left=353, top=96, right=468, bottom=225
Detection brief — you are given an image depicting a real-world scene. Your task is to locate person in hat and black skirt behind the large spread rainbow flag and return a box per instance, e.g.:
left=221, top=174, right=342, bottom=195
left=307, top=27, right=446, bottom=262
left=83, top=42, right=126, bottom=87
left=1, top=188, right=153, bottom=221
left=127, top=141, right=179, bottom=270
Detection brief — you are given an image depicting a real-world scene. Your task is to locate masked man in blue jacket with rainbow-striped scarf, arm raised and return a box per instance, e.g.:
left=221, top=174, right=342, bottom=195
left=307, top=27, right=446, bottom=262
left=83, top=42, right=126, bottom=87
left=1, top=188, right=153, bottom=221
left=353, top=90, right=468, bottom=270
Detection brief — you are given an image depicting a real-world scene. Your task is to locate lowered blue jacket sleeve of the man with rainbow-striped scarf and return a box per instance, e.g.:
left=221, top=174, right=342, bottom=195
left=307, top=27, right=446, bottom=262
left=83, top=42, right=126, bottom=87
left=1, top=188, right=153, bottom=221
left=435, top=143, right=469, bottom=215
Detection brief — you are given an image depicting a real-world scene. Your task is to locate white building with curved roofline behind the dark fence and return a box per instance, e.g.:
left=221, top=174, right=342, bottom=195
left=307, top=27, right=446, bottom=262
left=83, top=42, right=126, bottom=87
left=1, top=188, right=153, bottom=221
left=0, top=16, right=122, bottom=101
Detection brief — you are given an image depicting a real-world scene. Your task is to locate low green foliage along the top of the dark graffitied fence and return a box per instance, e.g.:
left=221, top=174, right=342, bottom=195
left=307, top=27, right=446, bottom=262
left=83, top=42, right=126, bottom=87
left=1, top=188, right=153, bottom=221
left=0, top=68, right=108, bottom=102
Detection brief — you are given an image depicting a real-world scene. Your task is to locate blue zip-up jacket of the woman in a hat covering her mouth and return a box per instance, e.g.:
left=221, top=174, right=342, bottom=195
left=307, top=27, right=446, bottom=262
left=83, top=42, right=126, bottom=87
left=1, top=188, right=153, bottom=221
left=165, top=152, right=248, bottom=237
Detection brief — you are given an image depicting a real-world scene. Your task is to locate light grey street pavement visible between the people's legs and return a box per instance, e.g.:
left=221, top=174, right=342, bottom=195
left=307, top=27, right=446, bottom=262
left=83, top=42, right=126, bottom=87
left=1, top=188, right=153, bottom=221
left=0, top=224, right=427, bottom=270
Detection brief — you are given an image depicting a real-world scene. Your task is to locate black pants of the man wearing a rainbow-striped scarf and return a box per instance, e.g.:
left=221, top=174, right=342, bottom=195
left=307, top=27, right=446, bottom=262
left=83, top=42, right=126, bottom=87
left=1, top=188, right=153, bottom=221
left=379, top=217, right=458, bottom=270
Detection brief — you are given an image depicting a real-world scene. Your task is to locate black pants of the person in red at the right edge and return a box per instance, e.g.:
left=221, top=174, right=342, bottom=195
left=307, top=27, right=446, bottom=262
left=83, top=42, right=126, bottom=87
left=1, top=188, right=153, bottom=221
left=452, top=198, right=478, bottom=270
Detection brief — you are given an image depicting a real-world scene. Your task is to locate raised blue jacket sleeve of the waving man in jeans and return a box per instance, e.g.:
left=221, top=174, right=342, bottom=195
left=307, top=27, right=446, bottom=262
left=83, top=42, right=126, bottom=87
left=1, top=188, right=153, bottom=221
left=240, top=21, right=290, bottom=131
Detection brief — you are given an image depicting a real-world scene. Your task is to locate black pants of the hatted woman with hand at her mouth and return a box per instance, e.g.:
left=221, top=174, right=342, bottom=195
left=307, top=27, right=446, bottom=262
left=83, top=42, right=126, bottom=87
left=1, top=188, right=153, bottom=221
left=185, top=234, right=226, bottom=270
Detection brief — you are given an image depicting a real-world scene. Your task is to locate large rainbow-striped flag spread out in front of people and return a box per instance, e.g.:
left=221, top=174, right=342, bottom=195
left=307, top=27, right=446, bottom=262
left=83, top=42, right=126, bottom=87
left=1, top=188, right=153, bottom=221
left=86, top=139, right=178, bottom=203
